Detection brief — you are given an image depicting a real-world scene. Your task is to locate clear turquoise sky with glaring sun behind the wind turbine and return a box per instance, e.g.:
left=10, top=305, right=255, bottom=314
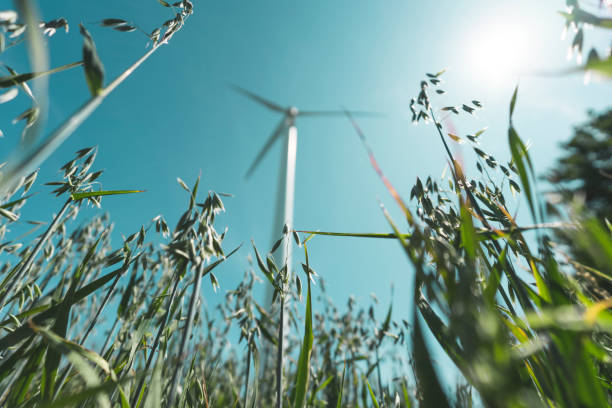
left=0, top=0, right=612, bottom=388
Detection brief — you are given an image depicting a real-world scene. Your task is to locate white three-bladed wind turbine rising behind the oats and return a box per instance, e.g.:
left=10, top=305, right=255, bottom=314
left=231, top=85, right=377, bottom=407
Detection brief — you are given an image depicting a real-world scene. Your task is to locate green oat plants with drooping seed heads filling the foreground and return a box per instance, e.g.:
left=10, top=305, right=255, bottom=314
left=0, top=1, right=612, bottom=408
